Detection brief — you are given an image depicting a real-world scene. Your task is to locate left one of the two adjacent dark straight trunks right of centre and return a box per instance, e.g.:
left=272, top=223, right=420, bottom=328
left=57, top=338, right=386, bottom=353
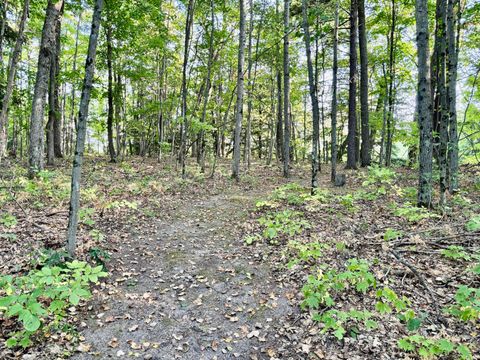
left=346, top=0, right=358, bottom=169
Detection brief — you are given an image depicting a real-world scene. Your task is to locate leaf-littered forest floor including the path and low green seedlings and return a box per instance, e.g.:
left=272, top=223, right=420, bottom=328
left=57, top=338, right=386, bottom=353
left=0, top=158, right=480, bottom=359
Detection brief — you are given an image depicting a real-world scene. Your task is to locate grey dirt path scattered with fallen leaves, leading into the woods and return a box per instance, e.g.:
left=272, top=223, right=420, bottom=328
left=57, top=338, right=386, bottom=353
left=74, top=187, right=296, bottom=360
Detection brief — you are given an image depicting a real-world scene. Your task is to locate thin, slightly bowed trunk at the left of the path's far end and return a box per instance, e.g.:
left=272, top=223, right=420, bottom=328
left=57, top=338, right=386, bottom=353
left=180, top=0, right=195, bottom=179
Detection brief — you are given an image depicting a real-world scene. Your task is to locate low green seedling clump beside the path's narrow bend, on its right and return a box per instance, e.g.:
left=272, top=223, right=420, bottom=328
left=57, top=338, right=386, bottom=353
left=258, top=210, right=310, bottom=243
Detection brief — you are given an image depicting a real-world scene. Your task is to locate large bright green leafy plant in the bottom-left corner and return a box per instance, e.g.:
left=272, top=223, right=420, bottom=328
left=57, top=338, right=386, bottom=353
left=0, top=260, right=107, bottom=348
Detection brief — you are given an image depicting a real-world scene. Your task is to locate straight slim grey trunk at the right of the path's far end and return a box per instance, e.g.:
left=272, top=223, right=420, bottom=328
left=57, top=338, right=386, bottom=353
left=232, top=0, right=245, bottom=181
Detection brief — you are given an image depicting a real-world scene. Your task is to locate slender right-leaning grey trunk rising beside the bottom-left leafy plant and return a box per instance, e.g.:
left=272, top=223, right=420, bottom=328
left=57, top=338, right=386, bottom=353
left=67, top=0, right=103, bottom=256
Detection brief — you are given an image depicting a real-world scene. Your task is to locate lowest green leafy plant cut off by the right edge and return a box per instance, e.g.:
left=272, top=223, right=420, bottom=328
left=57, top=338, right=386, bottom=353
left=445, top=285, right=480, bottom=322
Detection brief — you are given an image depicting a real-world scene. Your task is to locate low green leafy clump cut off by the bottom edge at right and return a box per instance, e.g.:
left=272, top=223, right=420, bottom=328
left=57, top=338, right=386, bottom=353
left=398, top=334, right=473, bottom=360
